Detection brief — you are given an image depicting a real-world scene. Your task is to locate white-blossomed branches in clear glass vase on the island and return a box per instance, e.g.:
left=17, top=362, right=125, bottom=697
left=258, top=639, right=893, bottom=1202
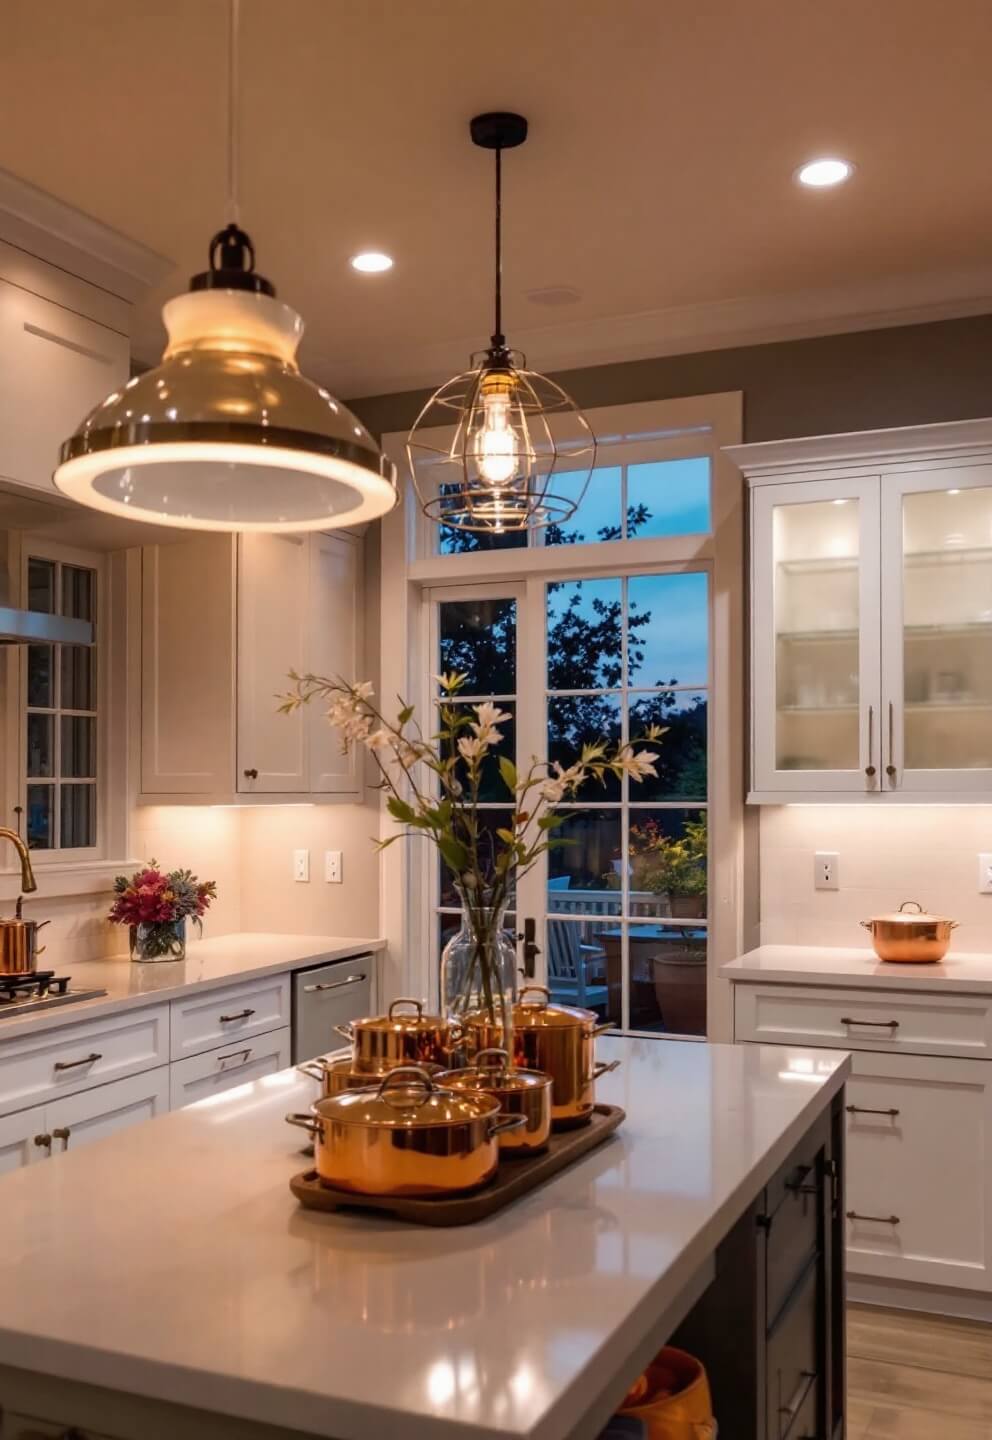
left=281, top=672, right=664, bottom=1035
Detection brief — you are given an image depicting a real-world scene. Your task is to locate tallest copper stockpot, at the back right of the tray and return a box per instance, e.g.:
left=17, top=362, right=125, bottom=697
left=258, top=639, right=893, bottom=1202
left=465, top=985, right=619, bottom=1130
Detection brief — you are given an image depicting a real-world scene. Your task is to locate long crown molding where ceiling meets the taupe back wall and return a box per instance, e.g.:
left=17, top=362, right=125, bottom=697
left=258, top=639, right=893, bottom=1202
left=338, top=266, right=992, bottom=399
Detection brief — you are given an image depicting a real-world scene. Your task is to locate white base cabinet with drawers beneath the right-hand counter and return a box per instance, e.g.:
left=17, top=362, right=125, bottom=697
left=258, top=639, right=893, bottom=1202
left=734, top=973, right=992, bottom=1309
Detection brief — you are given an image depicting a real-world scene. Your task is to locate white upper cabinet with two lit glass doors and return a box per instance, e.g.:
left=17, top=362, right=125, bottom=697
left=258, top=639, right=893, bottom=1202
left=730, top=420, right=992, bottom=804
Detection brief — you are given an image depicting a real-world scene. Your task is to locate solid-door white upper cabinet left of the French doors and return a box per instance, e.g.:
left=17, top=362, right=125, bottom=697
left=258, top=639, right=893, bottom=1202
left=141, top=534, right=361, bottom=804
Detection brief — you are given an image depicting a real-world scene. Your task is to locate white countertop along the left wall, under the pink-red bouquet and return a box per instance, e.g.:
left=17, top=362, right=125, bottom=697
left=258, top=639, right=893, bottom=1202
left=0, top=932, right=386, bottom=1044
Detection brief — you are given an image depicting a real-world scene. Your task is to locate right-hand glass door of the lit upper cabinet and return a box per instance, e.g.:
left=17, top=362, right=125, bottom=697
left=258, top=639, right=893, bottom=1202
left=883, top=465, right=992, bottom=795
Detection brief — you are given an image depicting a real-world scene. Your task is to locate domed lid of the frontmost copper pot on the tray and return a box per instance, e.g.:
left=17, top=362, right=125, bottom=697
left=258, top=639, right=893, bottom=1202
left=311, top=1066, right=500, bottom=1130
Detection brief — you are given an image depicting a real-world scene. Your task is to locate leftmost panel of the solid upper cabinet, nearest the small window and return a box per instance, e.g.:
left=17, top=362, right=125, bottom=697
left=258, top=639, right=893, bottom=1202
left=141, top=534, right=235, bottom=796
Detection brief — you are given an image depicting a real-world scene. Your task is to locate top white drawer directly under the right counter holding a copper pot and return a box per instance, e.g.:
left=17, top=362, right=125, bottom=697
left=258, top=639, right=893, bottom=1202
left=734, top=985, right=992, bottom=1060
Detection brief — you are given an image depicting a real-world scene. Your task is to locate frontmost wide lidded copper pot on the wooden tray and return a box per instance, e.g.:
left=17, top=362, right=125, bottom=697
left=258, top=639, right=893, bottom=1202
left=287, top=1066, right=524, bottom=1195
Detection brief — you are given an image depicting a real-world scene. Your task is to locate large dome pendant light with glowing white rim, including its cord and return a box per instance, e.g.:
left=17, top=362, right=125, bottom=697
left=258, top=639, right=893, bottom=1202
left=55, top=0, right=396, bottom=531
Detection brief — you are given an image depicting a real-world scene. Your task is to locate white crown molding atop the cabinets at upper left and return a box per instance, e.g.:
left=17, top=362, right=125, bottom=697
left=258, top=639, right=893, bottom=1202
left=0, top=170, right=174, bottom=301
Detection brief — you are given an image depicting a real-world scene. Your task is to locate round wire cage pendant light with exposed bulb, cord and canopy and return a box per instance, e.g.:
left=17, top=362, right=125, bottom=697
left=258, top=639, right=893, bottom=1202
left=406, top=111, right=596, bottom=534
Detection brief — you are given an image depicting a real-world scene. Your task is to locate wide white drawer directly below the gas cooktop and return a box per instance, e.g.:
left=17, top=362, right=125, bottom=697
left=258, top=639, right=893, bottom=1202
left=0, top=1005, right=168, bottom=1115
